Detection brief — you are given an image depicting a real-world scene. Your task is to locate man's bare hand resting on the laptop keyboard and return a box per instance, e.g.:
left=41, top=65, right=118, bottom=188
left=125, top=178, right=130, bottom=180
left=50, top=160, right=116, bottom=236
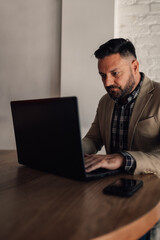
left=85, top=153, right=125, bottom=172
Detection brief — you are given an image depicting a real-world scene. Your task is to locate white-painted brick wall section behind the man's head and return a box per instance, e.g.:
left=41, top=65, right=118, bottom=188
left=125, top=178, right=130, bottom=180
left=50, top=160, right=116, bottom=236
left=115, top=0, right=160, bottom=82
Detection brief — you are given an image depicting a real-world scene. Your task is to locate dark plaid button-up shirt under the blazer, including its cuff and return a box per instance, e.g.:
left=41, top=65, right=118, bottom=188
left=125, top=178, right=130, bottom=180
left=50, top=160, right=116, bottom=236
left=111, top=73, right=144, bottom=173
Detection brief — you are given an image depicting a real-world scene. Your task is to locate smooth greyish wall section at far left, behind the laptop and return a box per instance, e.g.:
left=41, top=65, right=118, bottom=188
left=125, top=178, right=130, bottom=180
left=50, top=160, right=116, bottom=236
left=0, top=0, right=61, bottom=149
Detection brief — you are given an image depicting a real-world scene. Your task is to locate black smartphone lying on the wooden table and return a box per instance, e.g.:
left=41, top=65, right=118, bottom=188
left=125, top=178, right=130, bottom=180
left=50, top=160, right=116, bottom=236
left=103, top=178, right=143, bottom=197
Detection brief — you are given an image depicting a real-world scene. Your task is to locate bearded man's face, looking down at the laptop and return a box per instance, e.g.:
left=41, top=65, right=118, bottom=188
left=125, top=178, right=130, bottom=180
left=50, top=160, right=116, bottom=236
left=98, top=54, right=139, bottom=100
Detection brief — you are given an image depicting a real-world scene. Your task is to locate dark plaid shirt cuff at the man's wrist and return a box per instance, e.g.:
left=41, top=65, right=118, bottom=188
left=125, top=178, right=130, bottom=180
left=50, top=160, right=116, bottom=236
left=120, top=152, right=136, bottom=174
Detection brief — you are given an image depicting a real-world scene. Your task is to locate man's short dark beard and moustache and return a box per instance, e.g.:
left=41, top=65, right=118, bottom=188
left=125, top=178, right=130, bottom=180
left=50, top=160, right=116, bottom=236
left=105, top=73, right=135, bottom=101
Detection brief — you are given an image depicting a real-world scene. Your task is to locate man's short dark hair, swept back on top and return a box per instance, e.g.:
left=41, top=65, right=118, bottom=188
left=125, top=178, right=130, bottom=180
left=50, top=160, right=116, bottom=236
left=94, top=38, right=137, bottom=59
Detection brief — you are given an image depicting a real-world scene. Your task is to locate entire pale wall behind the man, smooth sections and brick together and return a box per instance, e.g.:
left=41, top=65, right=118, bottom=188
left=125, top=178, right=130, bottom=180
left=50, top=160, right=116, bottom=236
left=5, top=0, right=160, bottom=149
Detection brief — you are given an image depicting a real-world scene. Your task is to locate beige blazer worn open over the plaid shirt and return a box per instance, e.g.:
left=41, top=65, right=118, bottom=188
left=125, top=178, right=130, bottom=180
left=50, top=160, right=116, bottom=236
left=82, top=76, right=160, bottom=176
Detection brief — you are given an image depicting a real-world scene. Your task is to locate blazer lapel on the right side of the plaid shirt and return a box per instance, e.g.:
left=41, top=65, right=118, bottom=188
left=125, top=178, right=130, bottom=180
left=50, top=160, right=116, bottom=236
left=128, top=76, right=154, bottom=150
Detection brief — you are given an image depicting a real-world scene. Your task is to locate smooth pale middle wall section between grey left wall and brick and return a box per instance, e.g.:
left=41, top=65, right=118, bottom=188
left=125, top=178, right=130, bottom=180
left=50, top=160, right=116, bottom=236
left=61, top=0, right=114, bottom=136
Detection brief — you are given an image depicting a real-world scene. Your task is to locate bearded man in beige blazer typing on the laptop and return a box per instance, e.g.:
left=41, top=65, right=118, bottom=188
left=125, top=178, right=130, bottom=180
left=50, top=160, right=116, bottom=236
left=82, top=38, right=160, bottom=175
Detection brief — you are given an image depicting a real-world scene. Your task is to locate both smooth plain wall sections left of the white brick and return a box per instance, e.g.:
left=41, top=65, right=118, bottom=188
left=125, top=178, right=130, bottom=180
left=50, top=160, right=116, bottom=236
left=0, top=0, right=114, bottom=149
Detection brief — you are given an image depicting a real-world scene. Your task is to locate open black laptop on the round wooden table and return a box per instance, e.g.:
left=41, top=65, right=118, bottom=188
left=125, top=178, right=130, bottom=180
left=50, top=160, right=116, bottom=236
left=11, top=97, right=119, bottom=180
